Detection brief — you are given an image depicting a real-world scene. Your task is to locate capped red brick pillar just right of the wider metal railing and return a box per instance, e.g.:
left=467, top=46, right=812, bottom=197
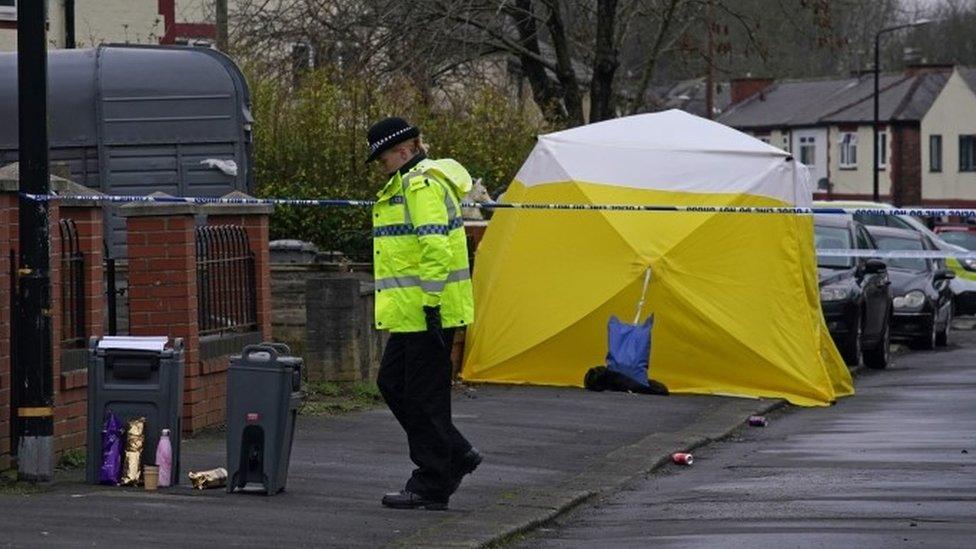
left=200, top=191, right=274, bottom=341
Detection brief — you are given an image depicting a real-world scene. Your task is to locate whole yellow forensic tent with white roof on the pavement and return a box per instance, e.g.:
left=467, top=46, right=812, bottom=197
left=462, top=110, right=853, bottom=406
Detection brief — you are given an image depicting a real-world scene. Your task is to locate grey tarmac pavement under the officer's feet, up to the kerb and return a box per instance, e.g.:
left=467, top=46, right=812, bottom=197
left=0, top=378, right=780, bottom=547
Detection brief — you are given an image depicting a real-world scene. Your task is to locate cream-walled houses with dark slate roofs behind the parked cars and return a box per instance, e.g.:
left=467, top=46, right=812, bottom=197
left=718, top=65, right=976, bottom=207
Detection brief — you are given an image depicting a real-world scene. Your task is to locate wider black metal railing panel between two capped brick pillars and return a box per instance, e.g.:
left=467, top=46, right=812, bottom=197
left=196, top=225, right=257, bottom=335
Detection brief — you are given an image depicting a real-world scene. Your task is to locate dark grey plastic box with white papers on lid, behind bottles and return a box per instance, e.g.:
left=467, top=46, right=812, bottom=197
left=85, top=338, right=185, bottom=485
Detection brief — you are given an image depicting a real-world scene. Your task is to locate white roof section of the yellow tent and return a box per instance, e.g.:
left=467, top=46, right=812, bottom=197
left=515, top=110, right=812, bottom=206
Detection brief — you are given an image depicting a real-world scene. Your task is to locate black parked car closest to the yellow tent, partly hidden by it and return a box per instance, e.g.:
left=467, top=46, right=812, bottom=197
left=813, top=215, right=892, bottom=368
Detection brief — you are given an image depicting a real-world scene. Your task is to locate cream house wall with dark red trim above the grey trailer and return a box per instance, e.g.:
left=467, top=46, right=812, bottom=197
left=0, top=0, right=217, bottom=51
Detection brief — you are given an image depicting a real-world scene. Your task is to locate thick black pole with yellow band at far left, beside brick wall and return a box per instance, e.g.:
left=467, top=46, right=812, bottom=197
left=13, top=1, right=54, bottom=481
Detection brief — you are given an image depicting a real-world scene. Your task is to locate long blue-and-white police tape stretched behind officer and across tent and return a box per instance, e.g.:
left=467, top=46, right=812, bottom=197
left=13, top=193, right=976, bottom=218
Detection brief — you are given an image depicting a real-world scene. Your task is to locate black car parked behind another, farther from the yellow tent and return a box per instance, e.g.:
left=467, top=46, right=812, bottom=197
left=868, top=227, right=955, bottom=349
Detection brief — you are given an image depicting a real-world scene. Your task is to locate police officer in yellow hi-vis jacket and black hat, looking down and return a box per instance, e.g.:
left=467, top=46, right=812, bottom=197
left=367, top=118, right=481, bottom=510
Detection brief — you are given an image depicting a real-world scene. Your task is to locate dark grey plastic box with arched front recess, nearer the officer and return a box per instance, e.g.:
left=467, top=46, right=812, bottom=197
left=227, top=343, right=302, bottom=495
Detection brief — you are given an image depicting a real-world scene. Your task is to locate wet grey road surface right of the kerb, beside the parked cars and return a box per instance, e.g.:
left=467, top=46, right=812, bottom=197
left=516, top=322, right=976, bottom=549
